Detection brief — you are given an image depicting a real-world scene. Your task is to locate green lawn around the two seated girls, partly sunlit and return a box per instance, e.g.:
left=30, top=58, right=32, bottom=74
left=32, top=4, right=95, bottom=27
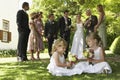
left=0, top=54, right=120, bottom=80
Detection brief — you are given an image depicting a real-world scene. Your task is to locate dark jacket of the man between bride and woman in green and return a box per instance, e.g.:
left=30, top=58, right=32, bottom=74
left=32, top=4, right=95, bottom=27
left=84, top=15, right=98, bottom=32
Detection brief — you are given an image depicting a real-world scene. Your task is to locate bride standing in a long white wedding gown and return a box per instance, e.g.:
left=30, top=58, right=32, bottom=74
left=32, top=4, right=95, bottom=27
left=70, top=14, right=85, bottom=59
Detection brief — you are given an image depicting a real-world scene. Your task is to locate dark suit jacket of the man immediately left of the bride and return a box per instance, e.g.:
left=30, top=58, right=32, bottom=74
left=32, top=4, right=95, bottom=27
left=59, top=17, right=71, bottom=37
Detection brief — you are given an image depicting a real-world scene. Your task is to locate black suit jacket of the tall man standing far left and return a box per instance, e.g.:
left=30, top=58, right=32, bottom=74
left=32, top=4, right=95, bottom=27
left=16, top=10, right=30, bottom=32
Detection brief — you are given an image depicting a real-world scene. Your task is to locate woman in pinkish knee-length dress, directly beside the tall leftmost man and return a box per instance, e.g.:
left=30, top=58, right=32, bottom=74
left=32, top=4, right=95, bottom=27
left=28, top=12, right=38, bottom=60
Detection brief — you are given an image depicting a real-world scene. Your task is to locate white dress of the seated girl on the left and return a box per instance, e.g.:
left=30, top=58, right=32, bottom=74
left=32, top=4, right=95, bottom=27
left=47, top=52, right=82, bottom=76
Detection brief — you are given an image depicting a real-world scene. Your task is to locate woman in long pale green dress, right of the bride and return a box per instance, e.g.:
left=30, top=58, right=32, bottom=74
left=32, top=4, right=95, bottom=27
left=95, top=4, right=107, bottom=48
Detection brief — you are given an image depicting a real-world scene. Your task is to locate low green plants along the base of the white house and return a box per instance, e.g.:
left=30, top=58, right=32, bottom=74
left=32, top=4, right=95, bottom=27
left=0, top=49, right=17, bottom=57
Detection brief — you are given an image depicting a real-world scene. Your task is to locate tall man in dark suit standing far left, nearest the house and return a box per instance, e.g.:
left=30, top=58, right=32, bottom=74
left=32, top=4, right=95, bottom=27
left=17, top=2, right=30, bottom=62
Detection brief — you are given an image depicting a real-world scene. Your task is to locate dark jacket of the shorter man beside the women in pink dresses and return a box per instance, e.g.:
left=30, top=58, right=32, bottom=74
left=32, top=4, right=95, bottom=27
left=44, top=20, right=58, bottom=38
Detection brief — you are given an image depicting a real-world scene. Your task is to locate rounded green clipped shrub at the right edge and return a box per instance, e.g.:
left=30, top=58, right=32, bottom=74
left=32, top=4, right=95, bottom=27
left=110, top=36, right=120, bottom=55
